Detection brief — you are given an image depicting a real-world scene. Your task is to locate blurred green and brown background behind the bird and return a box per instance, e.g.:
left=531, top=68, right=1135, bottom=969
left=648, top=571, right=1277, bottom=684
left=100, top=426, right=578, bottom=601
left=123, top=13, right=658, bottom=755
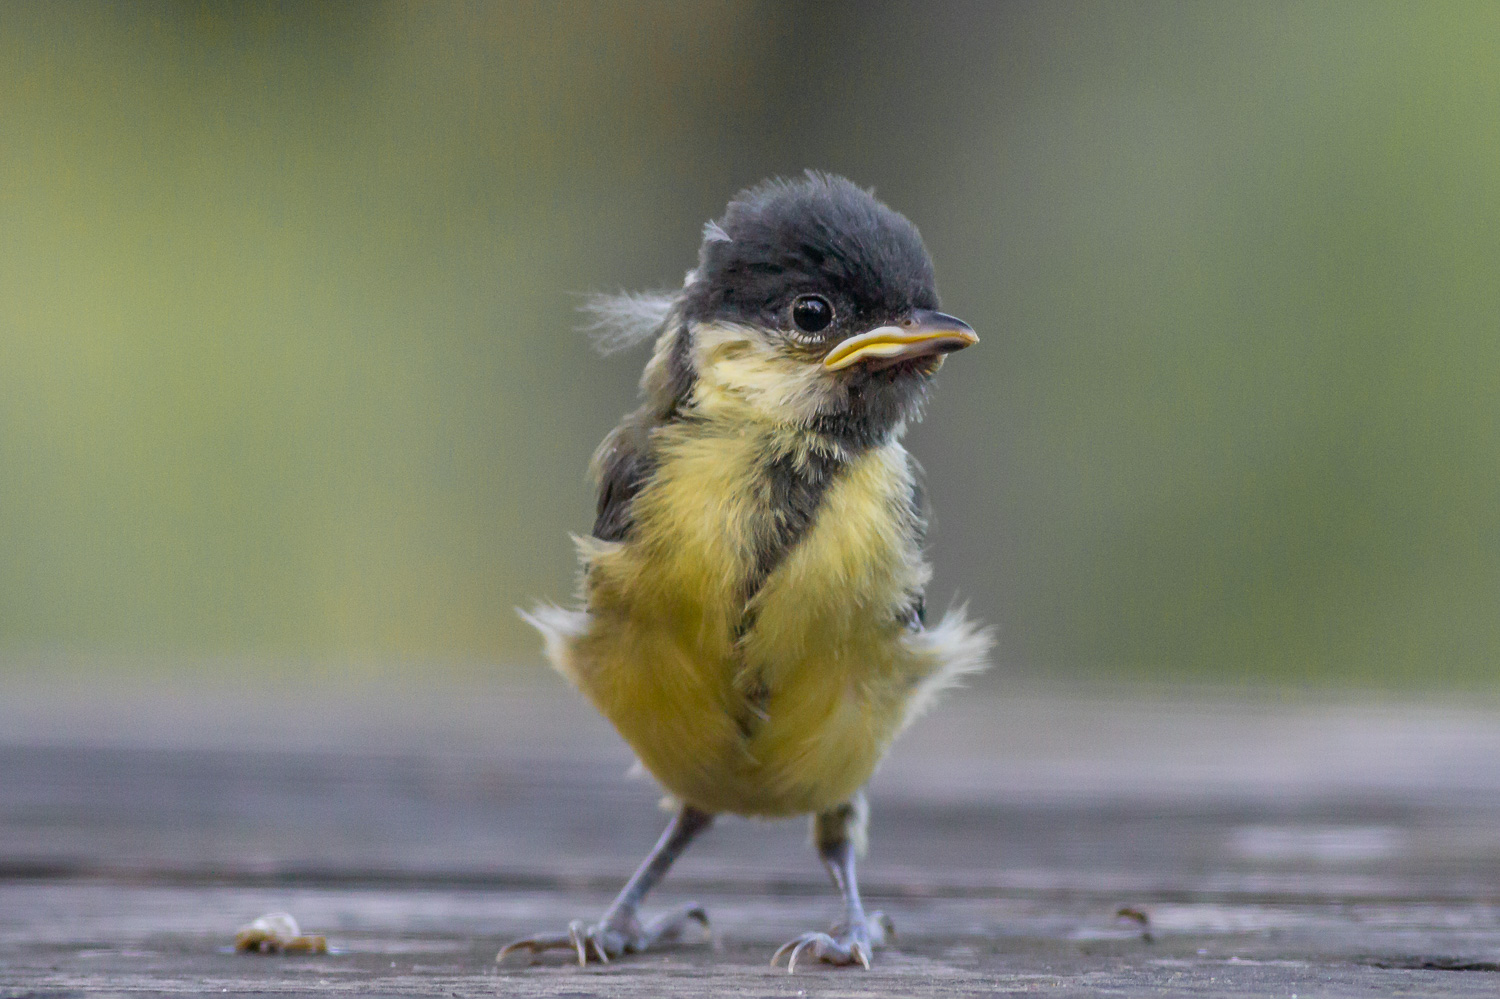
left=0, top=2, right=1500, bottom=690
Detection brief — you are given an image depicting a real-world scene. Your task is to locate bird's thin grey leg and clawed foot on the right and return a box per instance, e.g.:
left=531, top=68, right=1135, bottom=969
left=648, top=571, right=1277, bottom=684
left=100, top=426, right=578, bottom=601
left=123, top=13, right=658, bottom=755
left=771, top=792, right=896, bottom=972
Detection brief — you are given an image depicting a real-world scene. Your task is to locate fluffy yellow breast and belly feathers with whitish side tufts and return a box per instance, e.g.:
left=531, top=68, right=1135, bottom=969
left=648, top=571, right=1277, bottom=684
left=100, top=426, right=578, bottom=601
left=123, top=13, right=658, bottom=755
left=534, top=437, right=984, bottom=816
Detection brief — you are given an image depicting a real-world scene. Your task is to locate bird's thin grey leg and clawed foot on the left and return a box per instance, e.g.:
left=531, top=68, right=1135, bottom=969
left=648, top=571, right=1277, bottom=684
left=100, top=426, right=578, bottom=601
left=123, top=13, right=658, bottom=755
left=495, top=806, right=714, bottom=965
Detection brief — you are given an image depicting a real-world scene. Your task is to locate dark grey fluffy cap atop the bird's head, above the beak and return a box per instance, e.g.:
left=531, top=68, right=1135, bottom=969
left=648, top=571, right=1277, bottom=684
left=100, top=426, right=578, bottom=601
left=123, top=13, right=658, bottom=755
left=683, top=171, right=938, bottom=339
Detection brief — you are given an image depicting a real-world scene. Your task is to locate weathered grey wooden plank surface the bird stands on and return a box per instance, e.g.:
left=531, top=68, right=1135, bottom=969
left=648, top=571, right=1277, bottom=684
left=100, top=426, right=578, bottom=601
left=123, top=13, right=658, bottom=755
left=0, top=677, right=1500, bottom=998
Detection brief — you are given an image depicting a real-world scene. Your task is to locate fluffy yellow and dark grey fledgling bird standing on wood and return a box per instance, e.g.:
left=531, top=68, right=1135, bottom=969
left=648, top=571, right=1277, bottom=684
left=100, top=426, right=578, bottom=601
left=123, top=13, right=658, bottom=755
left=497, top=171, right=993, bottom=972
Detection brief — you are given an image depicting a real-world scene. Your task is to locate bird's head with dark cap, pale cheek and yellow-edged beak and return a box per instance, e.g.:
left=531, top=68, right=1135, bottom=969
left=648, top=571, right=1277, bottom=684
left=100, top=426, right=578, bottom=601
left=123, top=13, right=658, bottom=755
left=606, top=173, right=980, bottom=443
